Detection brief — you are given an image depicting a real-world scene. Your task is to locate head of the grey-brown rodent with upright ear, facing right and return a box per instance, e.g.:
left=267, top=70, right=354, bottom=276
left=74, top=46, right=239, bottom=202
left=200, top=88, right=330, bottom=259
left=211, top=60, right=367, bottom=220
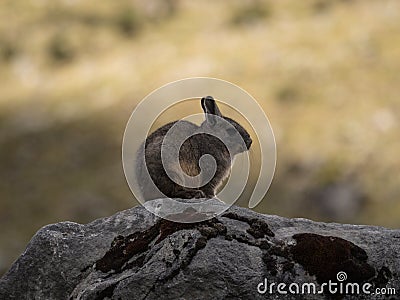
left=201, top=96, right=253, bottom=155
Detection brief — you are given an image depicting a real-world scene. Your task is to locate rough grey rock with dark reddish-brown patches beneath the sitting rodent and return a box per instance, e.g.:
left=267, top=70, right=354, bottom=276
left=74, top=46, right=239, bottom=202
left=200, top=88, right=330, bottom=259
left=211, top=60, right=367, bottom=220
left=0, top=199, right=400, bottom=299
